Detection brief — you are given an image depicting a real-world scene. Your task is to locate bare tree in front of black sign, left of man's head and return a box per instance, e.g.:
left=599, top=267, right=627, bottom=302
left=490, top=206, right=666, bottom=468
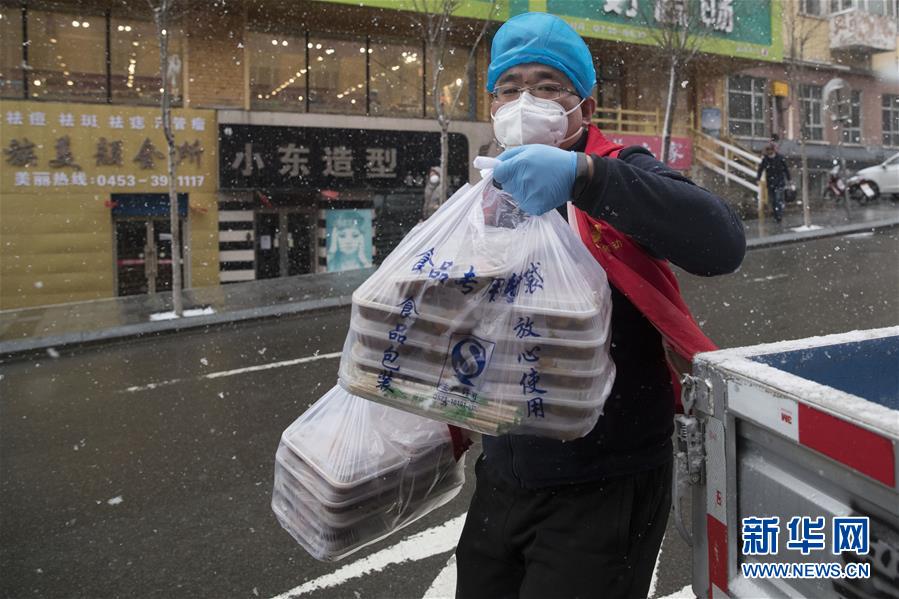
left=409, top=0, right=497, bottom=204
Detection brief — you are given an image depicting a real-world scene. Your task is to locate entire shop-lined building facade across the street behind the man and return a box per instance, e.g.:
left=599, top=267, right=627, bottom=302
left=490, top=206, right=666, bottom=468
left=0, top=0, right=899, bottom=309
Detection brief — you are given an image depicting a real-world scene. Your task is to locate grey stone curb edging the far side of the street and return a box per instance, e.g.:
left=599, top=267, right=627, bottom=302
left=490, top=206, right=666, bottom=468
left=0, top=217, right=899, bottom=362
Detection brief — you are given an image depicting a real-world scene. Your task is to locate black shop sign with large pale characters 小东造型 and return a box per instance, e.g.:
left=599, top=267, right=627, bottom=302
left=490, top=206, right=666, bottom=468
left=219, top=125, right=468, bottom=190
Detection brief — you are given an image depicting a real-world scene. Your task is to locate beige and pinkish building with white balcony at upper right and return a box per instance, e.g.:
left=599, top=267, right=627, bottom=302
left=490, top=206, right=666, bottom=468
left=722, top=0, right=899, bottom=188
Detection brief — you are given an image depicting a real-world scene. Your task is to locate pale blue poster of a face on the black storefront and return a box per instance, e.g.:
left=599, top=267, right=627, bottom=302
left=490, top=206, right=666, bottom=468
left=325, top=210, right=372, bottom=272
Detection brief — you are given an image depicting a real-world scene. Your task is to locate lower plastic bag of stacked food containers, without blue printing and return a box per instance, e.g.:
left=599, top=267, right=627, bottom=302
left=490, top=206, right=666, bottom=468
left=272, top=386, right=465, bottom=561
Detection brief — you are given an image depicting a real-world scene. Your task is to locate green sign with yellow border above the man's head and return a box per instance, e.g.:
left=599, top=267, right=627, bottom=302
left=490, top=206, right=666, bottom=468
left=528, top=0, right=783, bottom=61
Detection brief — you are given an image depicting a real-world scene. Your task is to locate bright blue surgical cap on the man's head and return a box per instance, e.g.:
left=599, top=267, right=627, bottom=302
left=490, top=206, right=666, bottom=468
left=487, top=12, right=596, bottom=98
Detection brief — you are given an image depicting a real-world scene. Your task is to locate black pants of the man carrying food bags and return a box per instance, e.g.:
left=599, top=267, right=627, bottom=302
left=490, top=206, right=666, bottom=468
left=456, top=458, right=671, bottom=599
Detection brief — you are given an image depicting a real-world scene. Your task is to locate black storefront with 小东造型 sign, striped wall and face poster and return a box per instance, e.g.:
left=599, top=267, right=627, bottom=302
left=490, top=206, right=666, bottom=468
left=219, top=124, right=469, bottom=283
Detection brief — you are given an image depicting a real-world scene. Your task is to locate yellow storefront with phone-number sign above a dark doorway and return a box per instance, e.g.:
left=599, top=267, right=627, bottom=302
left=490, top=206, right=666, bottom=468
left=0, top=100, right=218, bottom=309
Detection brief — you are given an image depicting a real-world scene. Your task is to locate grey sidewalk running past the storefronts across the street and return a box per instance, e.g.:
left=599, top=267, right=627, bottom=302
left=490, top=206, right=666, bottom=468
left=0, top=200, right=899, bottom=358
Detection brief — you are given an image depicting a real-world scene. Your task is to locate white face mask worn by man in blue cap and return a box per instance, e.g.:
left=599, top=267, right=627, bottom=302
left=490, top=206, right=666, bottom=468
left=492, top=91, right=584, bottom=148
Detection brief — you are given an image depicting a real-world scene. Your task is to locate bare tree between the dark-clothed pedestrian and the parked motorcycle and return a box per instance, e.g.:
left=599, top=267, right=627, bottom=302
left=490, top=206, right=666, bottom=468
left=783, top=3, right=826, bottom=227
